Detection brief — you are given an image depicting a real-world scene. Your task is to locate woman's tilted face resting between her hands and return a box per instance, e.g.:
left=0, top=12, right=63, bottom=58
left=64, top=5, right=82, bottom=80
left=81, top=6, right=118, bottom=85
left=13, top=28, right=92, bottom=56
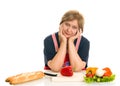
left=61, top=20, right=79, bottom=38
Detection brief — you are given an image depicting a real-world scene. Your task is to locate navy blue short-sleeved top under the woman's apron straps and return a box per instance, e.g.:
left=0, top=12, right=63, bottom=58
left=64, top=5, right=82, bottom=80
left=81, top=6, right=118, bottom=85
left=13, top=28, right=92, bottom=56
left=44, top=32, right=90, bottom=68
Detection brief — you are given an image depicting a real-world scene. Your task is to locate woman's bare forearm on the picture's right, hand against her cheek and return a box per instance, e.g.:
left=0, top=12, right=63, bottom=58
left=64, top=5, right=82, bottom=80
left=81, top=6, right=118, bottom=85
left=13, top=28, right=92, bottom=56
left=68, top=31, right=86, bottom=71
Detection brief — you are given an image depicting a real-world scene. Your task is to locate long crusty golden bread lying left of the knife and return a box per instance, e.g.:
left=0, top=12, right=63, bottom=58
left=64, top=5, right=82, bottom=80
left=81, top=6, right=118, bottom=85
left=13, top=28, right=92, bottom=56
left=5, top=71, right=45, bottom=85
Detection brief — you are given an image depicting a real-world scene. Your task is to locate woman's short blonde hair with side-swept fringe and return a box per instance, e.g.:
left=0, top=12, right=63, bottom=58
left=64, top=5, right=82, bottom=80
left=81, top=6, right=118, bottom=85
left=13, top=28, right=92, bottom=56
left=60, top=10, right=84, bottom=32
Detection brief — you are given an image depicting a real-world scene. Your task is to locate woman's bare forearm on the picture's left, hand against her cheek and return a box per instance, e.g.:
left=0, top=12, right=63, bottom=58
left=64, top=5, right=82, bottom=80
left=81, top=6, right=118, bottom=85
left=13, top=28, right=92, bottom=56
left=48, top=28, right=67, bottom=72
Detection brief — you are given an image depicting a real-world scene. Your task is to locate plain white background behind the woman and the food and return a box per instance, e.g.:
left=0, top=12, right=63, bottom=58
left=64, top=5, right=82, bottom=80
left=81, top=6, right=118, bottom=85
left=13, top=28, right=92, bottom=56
left=0, top=0, right=120, bottom=84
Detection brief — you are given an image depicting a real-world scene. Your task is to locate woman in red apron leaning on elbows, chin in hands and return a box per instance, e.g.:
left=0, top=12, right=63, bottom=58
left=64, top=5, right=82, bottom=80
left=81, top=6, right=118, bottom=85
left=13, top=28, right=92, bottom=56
left=44, top=10, right=90, bottom=72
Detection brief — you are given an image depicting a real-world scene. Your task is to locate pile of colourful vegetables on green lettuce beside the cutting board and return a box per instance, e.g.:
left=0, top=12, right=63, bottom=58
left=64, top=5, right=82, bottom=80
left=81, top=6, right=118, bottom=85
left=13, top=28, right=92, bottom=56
left=84, top=67, right=115, bottom=83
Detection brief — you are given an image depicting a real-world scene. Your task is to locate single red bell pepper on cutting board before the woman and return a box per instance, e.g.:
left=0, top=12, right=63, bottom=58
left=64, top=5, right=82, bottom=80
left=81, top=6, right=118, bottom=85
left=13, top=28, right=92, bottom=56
left=60, top=66, right=73, bottom=76
